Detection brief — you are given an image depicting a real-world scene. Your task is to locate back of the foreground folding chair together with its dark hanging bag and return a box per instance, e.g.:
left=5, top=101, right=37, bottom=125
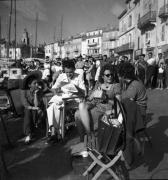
left=98, top=98, right=126, bottom=155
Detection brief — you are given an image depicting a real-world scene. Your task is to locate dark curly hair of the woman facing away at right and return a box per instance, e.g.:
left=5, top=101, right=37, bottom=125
left=118, top=62, right=137, bottom=80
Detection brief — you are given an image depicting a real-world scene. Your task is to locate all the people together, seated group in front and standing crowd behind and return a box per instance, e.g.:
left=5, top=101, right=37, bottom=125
left=10, top=53, right=168, bottom=167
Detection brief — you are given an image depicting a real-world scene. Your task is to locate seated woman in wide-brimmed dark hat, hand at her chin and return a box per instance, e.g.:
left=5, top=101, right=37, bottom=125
left=21, top=71, right=44, bottom=143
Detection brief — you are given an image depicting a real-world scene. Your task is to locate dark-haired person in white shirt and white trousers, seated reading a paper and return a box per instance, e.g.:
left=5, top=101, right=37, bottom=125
left=47, top=60, right=86, bottom=141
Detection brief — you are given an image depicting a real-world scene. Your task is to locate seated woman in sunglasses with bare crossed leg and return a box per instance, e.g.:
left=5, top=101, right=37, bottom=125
left=75, top=64, right=121, bottom=142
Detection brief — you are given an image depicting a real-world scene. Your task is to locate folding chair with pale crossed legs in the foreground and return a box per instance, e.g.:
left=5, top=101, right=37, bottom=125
left=83, top=98, right=126, bottom=180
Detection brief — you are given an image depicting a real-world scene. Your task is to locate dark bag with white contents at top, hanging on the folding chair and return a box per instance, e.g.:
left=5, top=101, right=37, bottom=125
left=97, top=115, right=122, bottom=155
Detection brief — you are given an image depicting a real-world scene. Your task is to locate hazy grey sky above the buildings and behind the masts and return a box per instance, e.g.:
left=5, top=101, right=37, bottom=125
left=0, top=0, right=125, bottom=44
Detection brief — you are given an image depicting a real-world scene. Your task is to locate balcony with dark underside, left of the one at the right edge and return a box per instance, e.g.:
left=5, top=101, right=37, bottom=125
left=138, top=11, right=156, bottom=30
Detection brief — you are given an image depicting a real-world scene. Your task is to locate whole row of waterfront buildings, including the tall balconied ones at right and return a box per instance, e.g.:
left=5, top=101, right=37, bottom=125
left=45, top=0, right=168, bottom=59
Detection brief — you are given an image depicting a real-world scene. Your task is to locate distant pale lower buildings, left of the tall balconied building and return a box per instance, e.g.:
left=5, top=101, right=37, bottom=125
left=45, top=27, right=118, bottom=58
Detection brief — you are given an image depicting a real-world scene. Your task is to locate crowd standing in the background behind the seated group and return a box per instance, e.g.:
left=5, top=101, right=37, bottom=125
left=36, top=52, right=168, bottom=90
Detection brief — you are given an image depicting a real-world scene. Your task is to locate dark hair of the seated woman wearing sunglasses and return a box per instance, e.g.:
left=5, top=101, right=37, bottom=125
left=99, top=64, right=119, bottom=83
